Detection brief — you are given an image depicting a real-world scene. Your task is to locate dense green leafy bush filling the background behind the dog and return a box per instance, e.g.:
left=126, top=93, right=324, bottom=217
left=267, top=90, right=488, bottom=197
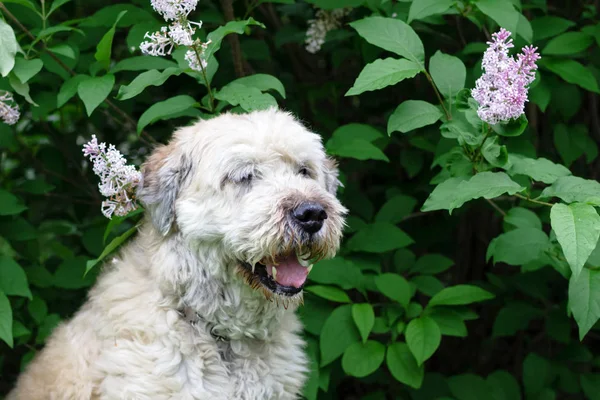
left=0, top=0, right=600, bottom=400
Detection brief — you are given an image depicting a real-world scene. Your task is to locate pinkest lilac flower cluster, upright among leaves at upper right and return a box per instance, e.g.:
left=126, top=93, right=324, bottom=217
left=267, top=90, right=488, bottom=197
left=471, top=28, right=540, bottom=125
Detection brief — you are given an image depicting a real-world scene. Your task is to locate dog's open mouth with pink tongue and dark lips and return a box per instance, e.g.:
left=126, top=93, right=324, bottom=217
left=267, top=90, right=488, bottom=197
left=241, top=254, right=312, bottom=296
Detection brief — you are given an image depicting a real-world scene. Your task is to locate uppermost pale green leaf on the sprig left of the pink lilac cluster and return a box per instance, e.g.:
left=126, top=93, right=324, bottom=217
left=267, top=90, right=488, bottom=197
left=349, top=17, right=425, bottom=69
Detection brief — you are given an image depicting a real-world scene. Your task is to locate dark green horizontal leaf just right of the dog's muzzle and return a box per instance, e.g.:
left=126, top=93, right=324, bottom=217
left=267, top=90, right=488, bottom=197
left=348, top=222, right=414, bottom=253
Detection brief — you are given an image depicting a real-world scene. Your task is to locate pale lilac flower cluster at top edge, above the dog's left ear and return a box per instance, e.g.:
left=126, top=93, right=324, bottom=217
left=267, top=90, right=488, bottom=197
left=140, top=0, right=210, bottom=71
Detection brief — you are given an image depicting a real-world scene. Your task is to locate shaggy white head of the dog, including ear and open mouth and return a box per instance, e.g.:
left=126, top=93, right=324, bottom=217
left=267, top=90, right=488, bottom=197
left=139, top=110, right=346, bottom=298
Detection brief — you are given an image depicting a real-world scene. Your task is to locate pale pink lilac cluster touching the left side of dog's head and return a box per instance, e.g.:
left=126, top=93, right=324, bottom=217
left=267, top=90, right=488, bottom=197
left=83, top=135, right=142, bottom=218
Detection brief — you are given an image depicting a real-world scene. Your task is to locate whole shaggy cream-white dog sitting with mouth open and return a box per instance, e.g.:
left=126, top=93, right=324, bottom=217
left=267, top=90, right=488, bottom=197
left=9, top=109, right=346, bottom=400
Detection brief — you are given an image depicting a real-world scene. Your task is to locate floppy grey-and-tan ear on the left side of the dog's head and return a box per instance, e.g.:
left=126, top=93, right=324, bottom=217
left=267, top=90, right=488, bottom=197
left=137, top=143, right=191, bottom=236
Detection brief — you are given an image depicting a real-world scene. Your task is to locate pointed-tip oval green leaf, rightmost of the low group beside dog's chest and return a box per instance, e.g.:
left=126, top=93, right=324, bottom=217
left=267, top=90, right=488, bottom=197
left=404, top=316, right=442, bottom=365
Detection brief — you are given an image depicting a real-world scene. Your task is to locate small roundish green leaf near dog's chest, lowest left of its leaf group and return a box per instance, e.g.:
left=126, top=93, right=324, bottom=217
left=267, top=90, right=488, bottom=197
left=342, top=340, right=385, bottom=378
